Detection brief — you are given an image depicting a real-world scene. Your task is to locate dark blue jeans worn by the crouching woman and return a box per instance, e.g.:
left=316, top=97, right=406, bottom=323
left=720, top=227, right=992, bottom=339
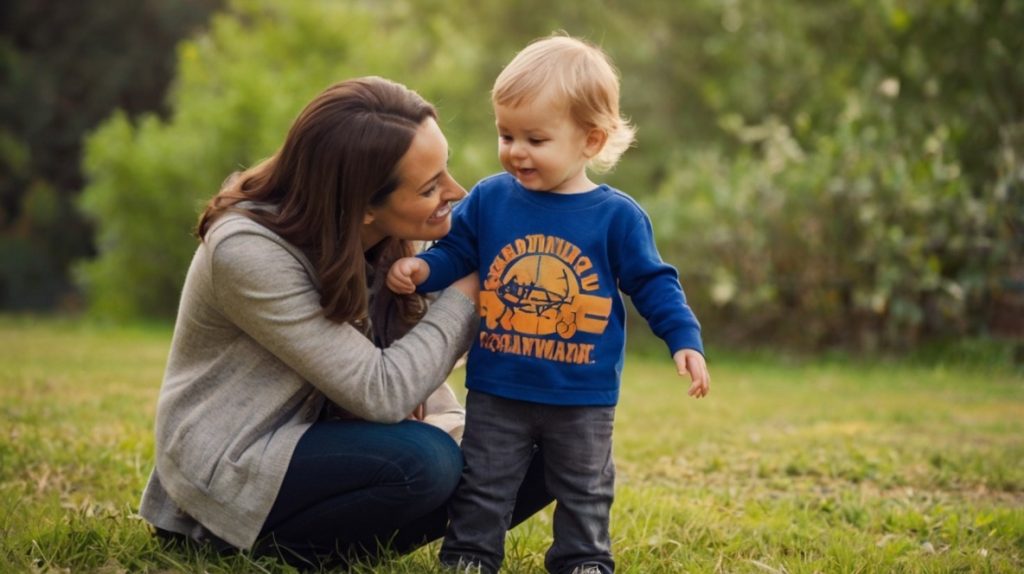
left=257, top=421, right=552, bottom=566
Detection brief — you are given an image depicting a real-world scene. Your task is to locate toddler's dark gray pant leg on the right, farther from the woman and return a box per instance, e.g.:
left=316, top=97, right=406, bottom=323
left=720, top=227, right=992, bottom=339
left=541, top=406, right=615, bottom=573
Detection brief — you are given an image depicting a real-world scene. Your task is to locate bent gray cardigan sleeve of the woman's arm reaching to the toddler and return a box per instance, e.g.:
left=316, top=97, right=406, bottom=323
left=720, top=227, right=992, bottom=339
left=210, top=228, right=475, bottom=423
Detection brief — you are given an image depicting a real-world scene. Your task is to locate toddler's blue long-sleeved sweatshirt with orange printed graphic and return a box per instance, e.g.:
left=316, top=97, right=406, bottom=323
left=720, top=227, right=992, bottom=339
left=419, top=173, right=703, bottom=406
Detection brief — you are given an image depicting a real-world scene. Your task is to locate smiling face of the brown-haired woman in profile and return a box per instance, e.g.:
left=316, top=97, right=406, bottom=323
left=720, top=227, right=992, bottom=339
left=361, top=118, right=466, bottom=250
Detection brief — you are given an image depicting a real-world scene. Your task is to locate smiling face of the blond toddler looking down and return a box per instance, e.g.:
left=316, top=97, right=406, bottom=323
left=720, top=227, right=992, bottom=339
left=495, top=95, right=603, bottom=193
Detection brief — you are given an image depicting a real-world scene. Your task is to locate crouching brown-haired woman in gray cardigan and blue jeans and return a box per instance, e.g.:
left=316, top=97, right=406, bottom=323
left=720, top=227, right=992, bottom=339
left=140, top=78, right=550, bottom=565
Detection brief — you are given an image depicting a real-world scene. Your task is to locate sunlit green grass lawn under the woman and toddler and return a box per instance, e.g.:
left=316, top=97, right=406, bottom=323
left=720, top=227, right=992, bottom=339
left=0, top=317, right=1024, bottom=574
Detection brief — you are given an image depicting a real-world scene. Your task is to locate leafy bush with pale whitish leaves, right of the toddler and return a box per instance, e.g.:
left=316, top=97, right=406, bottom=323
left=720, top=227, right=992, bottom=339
left=650, top=89, right=1021, bottom=349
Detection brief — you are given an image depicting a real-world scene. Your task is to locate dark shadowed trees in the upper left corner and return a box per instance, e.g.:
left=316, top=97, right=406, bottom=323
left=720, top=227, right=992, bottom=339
left=0, top=0, right=220, bottom=309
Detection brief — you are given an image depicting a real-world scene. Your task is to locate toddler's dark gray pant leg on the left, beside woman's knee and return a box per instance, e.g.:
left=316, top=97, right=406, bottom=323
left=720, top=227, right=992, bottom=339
left=439, top=391, right=535, bottom=572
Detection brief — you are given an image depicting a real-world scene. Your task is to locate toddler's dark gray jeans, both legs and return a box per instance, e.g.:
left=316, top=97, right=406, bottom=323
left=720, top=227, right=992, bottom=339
left=440, top=391, right=615, bottom=574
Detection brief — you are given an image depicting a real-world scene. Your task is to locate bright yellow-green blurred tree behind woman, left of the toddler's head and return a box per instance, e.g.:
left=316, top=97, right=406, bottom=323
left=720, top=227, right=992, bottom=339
left=75, top=0, right=638, bottom=317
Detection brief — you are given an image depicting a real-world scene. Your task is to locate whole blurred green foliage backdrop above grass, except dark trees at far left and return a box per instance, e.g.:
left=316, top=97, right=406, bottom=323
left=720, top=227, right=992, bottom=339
left=75, top=0, right=1024, bottom=348
